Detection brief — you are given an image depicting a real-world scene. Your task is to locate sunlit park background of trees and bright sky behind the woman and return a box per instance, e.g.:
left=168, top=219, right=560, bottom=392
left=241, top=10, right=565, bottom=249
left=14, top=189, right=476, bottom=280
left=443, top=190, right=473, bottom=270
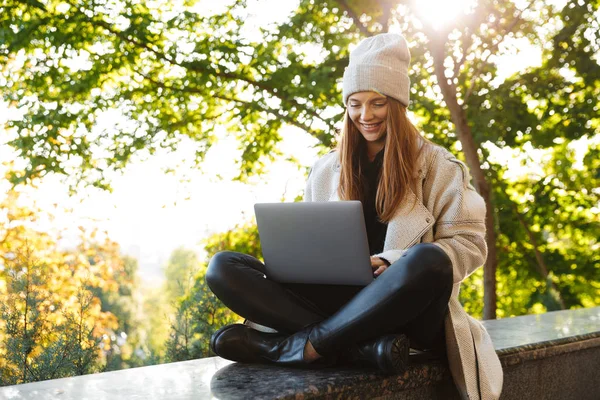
left=0, top=0, right=600, bottom=385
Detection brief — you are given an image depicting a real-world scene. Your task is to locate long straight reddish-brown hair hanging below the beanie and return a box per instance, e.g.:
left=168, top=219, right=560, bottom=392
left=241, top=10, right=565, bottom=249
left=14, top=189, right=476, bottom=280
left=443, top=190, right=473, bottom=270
left=337, top=97, right=429, bottom=223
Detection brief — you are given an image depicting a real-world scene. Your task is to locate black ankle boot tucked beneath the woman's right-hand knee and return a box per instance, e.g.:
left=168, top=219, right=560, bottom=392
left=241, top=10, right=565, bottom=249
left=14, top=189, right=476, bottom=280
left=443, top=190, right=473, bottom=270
left=350, top=335, right=410, bottom=374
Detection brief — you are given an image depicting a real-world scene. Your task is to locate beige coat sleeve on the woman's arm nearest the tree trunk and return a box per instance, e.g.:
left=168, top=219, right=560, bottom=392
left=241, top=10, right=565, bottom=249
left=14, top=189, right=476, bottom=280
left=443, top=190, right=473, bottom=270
left=425, top=152, right=487, bottom=283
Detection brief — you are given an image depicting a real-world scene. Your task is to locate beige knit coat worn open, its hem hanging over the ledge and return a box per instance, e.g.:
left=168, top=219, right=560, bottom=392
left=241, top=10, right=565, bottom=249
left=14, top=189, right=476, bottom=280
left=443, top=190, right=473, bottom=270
left=305, top=144, right=503, bottom=400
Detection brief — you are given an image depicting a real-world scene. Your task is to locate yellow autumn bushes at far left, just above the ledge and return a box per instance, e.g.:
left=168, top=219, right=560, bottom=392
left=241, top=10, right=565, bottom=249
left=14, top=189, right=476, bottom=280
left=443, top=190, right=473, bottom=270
left=0, top=191, right=153, bottom=385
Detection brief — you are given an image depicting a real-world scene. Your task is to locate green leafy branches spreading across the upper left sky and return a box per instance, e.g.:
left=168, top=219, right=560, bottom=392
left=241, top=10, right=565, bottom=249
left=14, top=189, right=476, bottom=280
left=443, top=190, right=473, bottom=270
left=0, top=0, right=349, bottom=188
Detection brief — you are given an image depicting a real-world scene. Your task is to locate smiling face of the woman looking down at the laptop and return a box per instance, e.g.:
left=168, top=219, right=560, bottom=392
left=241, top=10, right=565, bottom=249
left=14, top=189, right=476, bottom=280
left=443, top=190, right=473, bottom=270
left=346, top=92, right=388, bottom=155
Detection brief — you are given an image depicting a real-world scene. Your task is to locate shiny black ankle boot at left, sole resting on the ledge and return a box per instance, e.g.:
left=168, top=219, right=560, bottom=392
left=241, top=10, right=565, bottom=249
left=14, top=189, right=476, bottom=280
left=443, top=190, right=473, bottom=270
left=210, top=324, right=321, bottom=367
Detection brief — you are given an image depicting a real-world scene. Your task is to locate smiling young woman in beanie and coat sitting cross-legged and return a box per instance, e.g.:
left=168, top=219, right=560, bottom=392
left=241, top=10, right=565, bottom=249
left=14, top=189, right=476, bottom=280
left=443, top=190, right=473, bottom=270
left=206, top=34, right=502, bottom=399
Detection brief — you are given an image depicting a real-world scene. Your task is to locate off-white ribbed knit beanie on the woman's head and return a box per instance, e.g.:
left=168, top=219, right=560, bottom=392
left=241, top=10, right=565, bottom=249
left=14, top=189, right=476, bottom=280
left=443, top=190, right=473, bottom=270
left=343, top=33, right=410, bottom=107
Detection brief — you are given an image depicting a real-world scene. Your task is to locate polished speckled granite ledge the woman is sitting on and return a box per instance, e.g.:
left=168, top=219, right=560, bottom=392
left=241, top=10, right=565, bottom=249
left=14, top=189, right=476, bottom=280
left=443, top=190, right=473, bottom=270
left=0, top=307, right=600, bottom=400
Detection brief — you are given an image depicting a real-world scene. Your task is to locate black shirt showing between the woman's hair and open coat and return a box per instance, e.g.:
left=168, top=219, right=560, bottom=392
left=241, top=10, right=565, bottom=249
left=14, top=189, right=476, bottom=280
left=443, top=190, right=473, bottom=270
left=363, top=150, right=387, bottom=255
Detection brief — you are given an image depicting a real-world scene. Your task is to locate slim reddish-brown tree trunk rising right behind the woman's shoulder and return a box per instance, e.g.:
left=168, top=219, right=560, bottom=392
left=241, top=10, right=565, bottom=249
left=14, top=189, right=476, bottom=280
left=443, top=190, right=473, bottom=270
left=429, top=40, right=498, bottom=319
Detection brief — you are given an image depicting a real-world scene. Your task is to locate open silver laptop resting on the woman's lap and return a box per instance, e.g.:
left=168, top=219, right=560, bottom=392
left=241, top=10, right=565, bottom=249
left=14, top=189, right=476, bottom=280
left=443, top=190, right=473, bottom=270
left=254, top=201, right=373, bottom=286
